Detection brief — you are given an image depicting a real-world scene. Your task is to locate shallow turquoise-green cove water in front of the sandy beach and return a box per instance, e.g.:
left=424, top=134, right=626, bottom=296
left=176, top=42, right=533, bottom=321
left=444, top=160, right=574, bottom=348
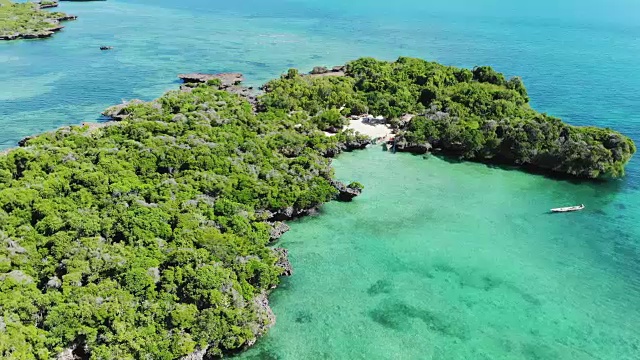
left=240, top=147, right=640, bottom=359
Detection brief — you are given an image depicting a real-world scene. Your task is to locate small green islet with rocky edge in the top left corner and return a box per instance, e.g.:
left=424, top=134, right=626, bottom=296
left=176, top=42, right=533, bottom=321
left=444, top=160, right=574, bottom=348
left=0, top=0, right=76, bottom=40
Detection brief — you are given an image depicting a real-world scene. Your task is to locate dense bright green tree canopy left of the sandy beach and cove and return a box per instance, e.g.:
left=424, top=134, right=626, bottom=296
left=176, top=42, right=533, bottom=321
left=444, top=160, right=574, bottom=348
left=0, top=84, right=364, bottom=359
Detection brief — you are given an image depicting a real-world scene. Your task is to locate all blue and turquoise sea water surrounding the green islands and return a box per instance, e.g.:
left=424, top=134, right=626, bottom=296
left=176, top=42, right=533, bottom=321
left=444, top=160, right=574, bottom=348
left=0, top=0, right=640, bottom=360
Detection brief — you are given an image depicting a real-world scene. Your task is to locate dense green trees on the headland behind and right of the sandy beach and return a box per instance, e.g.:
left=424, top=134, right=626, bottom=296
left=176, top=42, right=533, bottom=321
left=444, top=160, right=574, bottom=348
left=263, top=58, right=636, bottom=178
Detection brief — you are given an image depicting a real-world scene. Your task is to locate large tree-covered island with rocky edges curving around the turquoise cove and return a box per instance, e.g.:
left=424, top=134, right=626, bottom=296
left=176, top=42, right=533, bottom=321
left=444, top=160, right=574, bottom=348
left=0, top=58, right=635, bottom=359
